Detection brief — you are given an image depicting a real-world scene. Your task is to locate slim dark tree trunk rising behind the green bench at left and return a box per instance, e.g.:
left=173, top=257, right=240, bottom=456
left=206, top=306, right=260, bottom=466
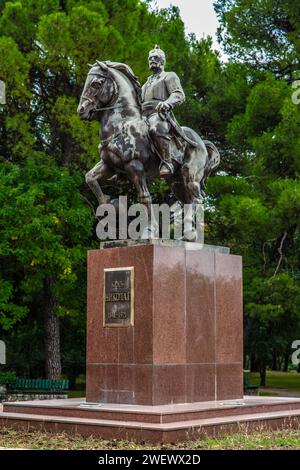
left=44, top=278, right=61, bottom=379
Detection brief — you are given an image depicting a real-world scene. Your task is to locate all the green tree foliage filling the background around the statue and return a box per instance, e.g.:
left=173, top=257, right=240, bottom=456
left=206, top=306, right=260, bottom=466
left=0, top=0, right=300, bottom=380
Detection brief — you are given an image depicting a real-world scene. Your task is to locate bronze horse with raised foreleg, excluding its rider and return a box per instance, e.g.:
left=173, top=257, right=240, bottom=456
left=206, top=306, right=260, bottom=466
left=78, top=61, right=220, bottom=241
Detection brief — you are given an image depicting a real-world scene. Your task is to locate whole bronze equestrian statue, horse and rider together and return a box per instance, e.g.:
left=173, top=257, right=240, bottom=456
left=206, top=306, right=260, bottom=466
left=78, top=47, right=220, bottom=241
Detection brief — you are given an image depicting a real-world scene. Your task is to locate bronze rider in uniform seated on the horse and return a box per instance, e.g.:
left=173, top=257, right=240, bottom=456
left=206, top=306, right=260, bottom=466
left=142, top=45, right=185, bottom=176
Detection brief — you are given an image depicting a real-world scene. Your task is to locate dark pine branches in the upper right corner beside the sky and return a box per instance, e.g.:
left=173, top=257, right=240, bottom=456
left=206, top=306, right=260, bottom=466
left=215, top=0, right=300, bottom=80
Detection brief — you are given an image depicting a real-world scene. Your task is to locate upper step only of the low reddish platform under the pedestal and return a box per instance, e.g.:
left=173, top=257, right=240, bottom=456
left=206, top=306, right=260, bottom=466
left=3, top=397, right=300, bottom=424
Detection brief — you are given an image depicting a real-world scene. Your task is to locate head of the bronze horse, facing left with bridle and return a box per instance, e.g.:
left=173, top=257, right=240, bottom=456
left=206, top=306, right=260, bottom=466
left=77, top=61, right=118, bottom=120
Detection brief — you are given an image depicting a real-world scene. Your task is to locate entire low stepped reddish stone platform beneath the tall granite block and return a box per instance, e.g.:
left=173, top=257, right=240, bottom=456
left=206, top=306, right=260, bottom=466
left=0, top=397, right=300, bottom=443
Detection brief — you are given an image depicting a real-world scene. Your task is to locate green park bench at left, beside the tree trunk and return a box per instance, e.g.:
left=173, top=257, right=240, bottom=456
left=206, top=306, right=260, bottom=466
left=8, top=378, right=69, bottom=394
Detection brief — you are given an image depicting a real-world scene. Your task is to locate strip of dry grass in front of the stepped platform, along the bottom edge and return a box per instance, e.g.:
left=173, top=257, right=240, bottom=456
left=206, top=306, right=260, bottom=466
left=0, top=426, right=300, bottom=450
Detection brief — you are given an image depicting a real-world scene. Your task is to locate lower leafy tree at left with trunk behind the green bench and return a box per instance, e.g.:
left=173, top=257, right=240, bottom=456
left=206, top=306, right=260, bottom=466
left=0, top=158, right=93, bottom=378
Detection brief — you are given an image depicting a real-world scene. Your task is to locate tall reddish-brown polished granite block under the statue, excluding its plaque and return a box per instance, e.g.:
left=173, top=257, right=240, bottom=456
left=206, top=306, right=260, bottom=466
left=86, top=244, right=243, bottom=405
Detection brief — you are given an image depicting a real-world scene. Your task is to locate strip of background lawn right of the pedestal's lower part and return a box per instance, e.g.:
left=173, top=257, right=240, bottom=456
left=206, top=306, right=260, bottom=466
left=249, top=371, right=300, bottom=393
